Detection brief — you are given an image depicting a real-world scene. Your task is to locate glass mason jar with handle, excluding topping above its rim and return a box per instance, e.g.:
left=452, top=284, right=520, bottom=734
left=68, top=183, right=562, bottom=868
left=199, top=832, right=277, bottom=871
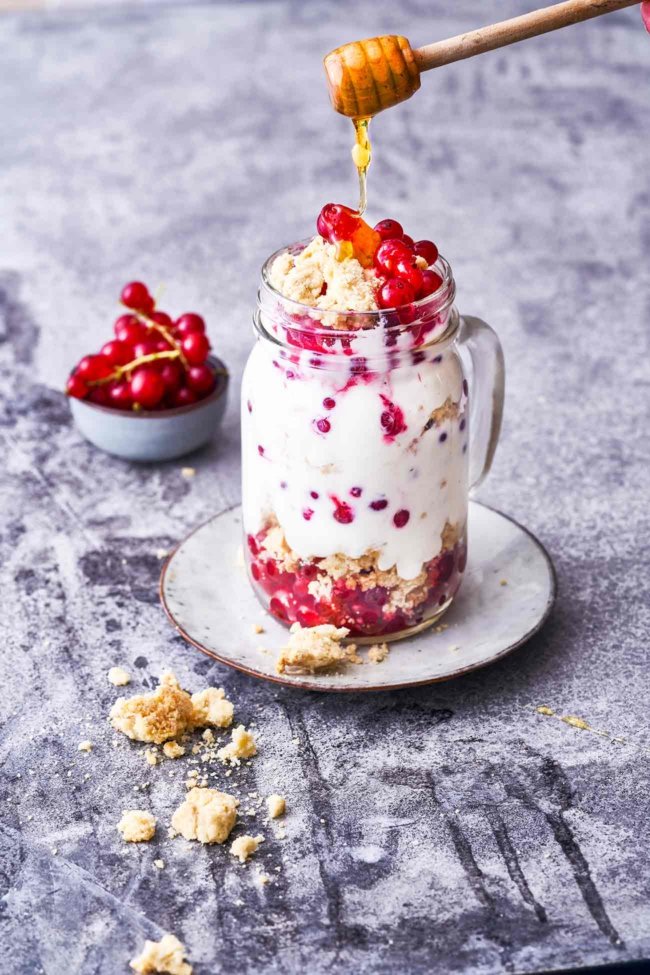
left=242, top=243, right=504, bottom=642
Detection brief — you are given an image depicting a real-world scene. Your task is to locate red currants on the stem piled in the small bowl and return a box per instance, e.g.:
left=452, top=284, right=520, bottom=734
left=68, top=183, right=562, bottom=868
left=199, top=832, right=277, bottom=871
left=66, top=281, right=215, bottom=410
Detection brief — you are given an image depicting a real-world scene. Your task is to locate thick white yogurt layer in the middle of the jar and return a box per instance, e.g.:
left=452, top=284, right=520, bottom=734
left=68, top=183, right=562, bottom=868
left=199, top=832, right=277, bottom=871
left=242, top=340, right=468, bottom=580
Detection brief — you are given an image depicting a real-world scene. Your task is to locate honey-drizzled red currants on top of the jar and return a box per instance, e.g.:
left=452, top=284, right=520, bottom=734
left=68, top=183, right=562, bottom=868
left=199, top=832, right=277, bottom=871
left=316, top=203, right=442, bottom=308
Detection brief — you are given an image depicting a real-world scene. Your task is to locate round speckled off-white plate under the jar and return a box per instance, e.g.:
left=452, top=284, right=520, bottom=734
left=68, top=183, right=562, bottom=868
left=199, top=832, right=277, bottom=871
left=160, top=501, right=556, bottom=692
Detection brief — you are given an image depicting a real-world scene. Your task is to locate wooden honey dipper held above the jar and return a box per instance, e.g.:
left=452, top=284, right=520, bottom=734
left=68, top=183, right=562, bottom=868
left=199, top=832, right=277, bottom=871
left=324, top=0, right=640, bottom=119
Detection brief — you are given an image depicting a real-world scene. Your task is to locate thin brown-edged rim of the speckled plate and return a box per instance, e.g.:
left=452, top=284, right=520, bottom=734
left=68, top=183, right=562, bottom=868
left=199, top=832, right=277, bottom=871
left=158, top=498, right=558, bottom=694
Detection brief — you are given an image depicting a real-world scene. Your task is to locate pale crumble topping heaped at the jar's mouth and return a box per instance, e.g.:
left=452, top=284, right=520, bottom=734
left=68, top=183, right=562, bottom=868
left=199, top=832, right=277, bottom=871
left=269, top=236, right=379, bottom=311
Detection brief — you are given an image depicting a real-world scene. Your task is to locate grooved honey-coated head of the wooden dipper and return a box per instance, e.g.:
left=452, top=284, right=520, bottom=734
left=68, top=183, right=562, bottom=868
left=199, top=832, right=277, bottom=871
left=323, top=34, right=420, bottom=118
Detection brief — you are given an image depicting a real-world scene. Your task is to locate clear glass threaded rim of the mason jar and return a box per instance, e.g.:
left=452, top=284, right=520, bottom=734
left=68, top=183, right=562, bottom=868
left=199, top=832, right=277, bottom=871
left=258, top=237, right=456, bottom=330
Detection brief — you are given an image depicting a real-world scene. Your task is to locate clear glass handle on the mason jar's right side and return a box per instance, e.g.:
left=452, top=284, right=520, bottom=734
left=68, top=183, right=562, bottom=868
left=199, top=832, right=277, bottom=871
left=459, top=315, right=506, bottom=491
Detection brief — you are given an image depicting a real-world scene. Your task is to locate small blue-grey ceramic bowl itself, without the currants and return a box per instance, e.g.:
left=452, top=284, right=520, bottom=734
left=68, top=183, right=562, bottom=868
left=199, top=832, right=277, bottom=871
left=70, top=356, right=229, bottom=461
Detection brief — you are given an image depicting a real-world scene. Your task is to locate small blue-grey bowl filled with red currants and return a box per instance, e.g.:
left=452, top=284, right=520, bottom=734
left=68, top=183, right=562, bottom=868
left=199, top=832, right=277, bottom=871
left=66, top=281, right=228, bottom=461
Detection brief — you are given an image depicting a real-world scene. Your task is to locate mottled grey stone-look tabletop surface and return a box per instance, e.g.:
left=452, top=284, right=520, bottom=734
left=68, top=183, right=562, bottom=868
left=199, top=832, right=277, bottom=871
left=0, top=0, right=650, bottom=975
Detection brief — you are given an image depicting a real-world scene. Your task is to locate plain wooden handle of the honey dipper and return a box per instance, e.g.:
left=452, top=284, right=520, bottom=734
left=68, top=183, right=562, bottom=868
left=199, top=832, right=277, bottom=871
left=413, top=0, right=640, bottom=71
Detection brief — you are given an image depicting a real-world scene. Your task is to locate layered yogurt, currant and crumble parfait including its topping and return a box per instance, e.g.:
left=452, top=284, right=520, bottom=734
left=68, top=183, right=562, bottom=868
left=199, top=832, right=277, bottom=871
left=242, top=204, right=500, bottom=642
